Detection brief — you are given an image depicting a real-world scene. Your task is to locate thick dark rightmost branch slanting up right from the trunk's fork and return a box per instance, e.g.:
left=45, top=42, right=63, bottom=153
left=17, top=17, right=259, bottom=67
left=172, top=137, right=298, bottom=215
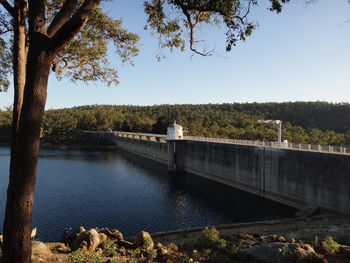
left=49, top=0, right=101, bottom=53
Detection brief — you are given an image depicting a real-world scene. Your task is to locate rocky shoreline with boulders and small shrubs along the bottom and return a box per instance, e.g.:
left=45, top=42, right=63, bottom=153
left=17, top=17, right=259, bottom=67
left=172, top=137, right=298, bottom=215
left=10, top=214, right=350, bottom=263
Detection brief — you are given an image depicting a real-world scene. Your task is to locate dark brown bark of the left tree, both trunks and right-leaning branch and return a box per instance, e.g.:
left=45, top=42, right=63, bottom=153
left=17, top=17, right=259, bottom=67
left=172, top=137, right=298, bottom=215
left=0, top=0, right=100, bottom=263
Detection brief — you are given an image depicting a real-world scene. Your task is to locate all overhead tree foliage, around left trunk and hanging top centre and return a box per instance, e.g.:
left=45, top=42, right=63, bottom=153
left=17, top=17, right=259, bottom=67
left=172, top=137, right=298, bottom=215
left=0, top=0, right=296, bottom=91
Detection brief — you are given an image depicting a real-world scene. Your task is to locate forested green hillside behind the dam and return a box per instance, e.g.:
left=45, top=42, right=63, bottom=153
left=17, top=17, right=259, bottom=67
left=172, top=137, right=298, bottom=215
left=0, top=102, right=350, bottom=146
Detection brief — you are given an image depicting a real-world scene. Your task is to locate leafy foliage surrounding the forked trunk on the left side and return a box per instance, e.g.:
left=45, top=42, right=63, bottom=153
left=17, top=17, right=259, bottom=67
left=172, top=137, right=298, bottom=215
left=0, top=0, right=139, bottom=91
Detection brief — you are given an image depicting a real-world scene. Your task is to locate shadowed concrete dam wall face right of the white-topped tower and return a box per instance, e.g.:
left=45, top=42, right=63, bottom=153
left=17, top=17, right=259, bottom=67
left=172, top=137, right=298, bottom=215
left=168, top=140, right=350, bottom=213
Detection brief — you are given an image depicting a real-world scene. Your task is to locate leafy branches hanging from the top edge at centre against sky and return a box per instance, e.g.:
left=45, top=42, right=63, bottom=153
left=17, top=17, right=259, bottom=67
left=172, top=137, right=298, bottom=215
left=144, top=0, right=257, bottom=56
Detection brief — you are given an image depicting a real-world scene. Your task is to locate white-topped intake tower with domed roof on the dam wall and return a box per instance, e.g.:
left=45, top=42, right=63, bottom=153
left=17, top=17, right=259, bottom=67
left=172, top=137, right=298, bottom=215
left=167, top=120, right=184, bottom=171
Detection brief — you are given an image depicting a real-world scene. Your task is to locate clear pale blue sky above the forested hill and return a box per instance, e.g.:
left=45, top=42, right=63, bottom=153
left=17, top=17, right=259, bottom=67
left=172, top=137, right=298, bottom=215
left=0, top=0, right=350, bottom=108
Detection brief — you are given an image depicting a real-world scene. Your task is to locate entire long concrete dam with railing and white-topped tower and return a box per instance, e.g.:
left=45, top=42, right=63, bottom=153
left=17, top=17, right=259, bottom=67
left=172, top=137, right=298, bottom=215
left=89, top=124, right=350, bottom=213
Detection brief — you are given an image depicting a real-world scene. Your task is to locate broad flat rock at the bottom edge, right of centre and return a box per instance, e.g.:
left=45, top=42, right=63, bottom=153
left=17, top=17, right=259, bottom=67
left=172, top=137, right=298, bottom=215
left=245, top=242, right=327, bottom=263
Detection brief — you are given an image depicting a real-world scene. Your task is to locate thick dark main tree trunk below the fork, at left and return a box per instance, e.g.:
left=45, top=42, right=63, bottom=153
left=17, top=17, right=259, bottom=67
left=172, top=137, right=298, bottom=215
left=2, top=40, right=52, bottom=263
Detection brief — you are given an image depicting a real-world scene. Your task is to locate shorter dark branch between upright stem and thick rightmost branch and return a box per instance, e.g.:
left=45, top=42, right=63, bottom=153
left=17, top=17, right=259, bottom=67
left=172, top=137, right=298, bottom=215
left=47, top=0, right=78, bottom=37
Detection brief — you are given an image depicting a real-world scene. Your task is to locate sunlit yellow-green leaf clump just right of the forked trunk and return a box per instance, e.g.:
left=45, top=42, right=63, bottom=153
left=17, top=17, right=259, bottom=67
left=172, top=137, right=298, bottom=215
left=52, top=8, right=139, bottom=85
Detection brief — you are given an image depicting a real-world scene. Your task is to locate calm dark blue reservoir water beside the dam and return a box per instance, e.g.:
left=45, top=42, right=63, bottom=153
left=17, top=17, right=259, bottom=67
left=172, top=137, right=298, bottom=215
left=0, top=147, right=295, bottom=241
